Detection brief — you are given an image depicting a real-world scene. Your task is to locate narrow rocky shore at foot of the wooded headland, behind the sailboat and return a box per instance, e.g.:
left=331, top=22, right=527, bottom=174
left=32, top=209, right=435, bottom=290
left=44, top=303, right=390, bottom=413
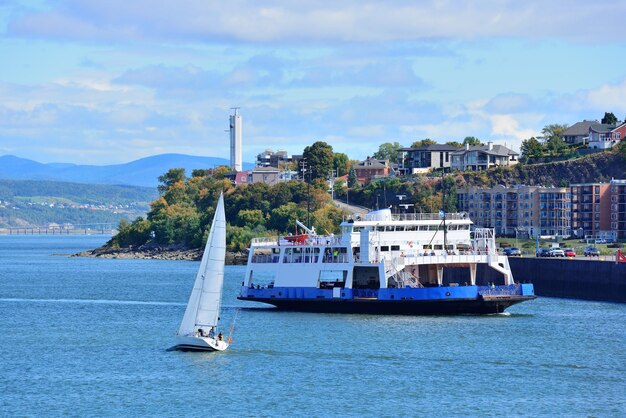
left=72, top=245, right=248, bottom=265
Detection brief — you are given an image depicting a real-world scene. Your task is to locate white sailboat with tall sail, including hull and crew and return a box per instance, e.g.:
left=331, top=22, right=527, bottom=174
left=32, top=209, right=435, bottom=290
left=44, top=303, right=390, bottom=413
left=173, top=193, right=230, bottom=351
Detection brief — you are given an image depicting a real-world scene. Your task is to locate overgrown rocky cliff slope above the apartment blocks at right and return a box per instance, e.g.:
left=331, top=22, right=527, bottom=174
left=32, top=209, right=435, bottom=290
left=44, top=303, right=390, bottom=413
left=463, top=152, right=626, bottom=186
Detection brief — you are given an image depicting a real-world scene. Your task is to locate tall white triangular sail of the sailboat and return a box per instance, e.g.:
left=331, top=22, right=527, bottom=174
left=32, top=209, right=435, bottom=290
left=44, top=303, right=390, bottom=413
left=178, top=194, right=226, bottom=335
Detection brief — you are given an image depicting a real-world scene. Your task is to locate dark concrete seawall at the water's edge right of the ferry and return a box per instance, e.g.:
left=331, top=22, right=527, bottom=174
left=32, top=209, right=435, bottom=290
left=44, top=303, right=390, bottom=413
left=509, top=257, right=626, bottom=302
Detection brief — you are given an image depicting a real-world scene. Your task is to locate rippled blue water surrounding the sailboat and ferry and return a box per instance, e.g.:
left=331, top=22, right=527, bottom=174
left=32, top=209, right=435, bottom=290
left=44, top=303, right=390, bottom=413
left=0, top=236, right=626, bottom=417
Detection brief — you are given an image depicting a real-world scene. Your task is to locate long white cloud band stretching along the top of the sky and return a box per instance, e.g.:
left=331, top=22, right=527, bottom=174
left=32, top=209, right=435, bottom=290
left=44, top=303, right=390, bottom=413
left=9, top=0, right=626, bottom=43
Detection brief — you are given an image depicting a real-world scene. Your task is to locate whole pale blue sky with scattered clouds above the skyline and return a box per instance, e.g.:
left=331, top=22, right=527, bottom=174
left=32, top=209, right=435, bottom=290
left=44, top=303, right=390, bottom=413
left=0, top=0, right=626, bottom=165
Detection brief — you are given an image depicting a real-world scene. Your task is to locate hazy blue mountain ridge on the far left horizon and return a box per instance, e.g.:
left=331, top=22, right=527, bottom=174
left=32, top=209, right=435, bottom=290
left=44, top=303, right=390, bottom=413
left=0, top=154, right=252, bottom=187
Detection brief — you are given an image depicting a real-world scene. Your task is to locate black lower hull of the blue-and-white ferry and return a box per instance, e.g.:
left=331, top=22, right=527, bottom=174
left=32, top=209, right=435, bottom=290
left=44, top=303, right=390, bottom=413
left=238, top=296, right=535, bottom=315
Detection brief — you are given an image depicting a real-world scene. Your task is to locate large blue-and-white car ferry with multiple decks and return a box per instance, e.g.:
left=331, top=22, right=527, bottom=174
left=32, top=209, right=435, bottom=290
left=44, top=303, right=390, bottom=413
left=238, top=209, right=536, bottom=315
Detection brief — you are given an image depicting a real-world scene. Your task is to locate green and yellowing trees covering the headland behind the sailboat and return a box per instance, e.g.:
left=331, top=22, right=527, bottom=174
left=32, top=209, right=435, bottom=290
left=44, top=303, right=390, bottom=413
left=107, top=168, right=345, bottom=251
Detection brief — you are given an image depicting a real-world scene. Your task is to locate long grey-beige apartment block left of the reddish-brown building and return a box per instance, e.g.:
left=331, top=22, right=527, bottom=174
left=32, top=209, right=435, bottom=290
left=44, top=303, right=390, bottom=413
left=457, top=185, right=571, bottom=237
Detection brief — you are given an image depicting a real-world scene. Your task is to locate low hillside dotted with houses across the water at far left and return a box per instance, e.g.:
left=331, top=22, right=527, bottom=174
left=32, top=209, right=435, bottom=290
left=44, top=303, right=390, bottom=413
left=0, top=180, right=158, bottom=228
